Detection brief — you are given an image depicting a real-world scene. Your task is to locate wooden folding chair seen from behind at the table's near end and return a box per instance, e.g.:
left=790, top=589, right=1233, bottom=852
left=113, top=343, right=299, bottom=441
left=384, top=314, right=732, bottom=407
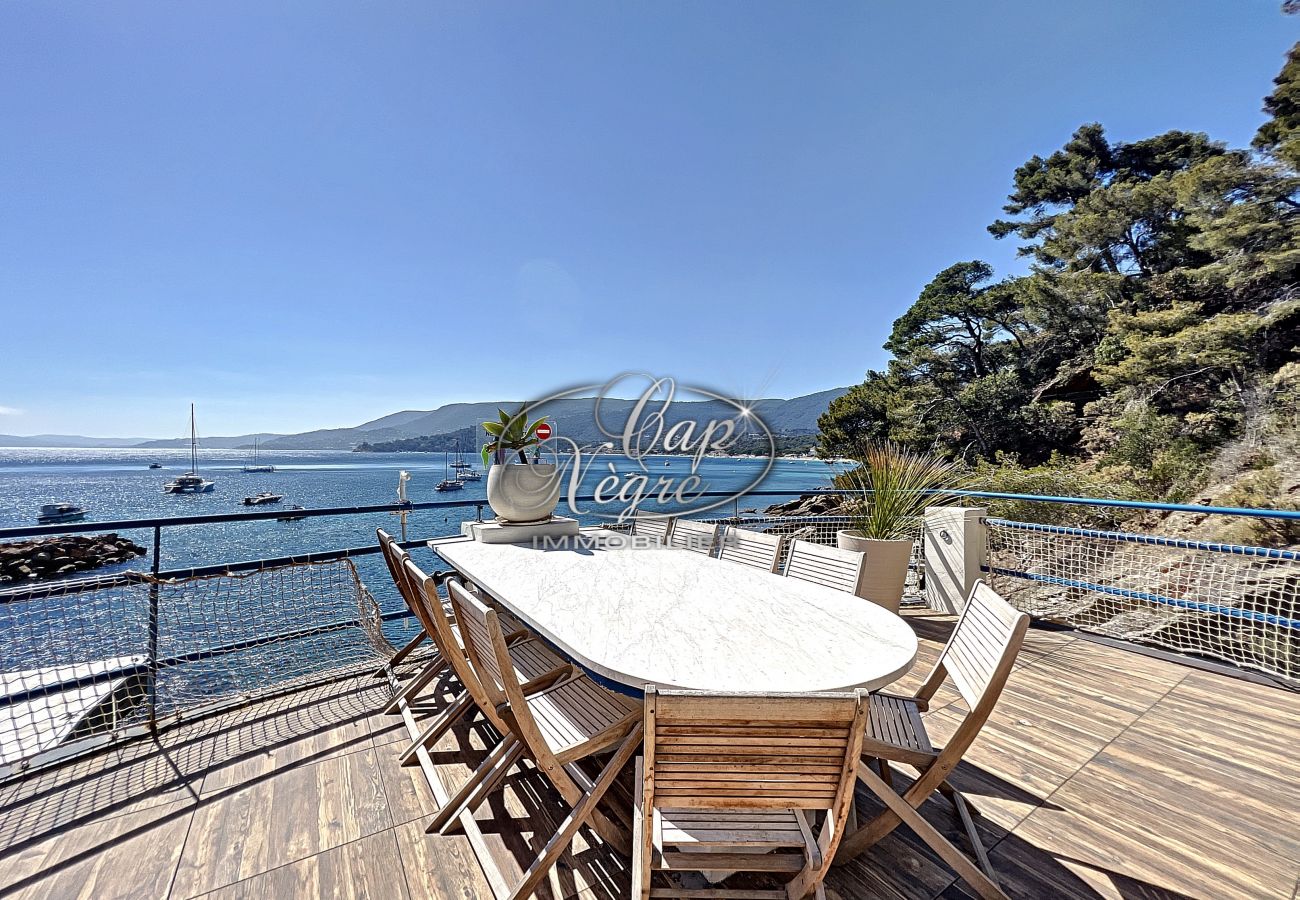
left=632, top=687, right=870, bottom=900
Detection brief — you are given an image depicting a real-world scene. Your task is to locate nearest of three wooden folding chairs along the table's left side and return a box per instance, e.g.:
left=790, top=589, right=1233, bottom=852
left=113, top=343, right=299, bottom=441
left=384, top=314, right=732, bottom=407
left=430, top=581, right=641, bottom=899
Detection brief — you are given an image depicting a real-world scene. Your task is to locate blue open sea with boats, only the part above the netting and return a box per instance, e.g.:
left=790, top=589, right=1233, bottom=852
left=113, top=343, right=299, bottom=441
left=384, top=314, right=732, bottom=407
left=0, top=449, right=842, bottom=582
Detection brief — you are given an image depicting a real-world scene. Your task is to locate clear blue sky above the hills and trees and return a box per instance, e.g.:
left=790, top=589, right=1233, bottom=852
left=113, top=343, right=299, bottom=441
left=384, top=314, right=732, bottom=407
left=0, top=0, right=1300, bottom=436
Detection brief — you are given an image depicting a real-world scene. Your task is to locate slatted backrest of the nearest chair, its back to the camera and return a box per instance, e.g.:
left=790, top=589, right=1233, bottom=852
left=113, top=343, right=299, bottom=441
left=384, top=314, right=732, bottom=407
left=644, top=685, right=868, bottom=814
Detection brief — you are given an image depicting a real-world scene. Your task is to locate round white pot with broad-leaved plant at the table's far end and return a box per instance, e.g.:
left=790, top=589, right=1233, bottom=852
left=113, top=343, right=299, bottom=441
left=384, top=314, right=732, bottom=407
left=482, top=410, right=560, bottom=524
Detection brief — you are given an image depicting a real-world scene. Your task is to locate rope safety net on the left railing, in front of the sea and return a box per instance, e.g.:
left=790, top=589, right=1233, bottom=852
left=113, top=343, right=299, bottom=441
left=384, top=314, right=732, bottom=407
left=0, top=559, right=395, bottom=778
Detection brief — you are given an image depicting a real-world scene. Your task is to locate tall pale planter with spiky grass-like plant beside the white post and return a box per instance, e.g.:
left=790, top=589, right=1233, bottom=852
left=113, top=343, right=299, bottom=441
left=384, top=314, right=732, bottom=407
left=836, top=441, right=962, bottom=613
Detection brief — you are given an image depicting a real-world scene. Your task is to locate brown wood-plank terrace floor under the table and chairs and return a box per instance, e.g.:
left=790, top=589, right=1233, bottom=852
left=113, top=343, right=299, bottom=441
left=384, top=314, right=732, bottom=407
left=0, top=615, right=1300, bottom=900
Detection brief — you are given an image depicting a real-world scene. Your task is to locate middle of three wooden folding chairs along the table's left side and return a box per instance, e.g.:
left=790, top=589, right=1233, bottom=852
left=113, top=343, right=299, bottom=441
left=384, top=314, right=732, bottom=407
left=399, top=567, right=573, bottom=769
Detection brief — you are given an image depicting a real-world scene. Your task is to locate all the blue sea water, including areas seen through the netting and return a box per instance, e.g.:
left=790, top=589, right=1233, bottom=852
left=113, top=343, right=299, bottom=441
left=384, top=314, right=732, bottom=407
left=0, top=449, right=842, bottom=711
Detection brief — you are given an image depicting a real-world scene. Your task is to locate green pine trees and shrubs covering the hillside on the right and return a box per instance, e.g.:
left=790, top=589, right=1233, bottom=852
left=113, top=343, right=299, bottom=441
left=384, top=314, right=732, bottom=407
left=819, top=44, right=1300, bottom=520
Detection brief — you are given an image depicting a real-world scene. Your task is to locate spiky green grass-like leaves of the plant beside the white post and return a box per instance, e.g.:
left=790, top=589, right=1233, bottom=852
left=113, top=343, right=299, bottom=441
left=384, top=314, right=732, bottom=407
left=836, top=441, right=966, bottom=541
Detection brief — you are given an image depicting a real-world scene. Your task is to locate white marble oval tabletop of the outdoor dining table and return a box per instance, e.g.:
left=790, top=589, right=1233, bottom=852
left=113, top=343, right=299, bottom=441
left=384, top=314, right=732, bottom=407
left=429, top=531, right=917, bottom=696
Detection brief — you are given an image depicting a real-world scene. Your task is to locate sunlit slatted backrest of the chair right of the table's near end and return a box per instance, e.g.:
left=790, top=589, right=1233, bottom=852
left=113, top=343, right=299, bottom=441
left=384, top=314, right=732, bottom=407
left=923, top=581, right=1030, bottom=711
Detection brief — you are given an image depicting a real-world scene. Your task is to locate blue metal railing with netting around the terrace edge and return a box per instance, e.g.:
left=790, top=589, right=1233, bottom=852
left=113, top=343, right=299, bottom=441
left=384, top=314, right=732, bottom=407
left=0, top=489, right=1300, bottom=778
